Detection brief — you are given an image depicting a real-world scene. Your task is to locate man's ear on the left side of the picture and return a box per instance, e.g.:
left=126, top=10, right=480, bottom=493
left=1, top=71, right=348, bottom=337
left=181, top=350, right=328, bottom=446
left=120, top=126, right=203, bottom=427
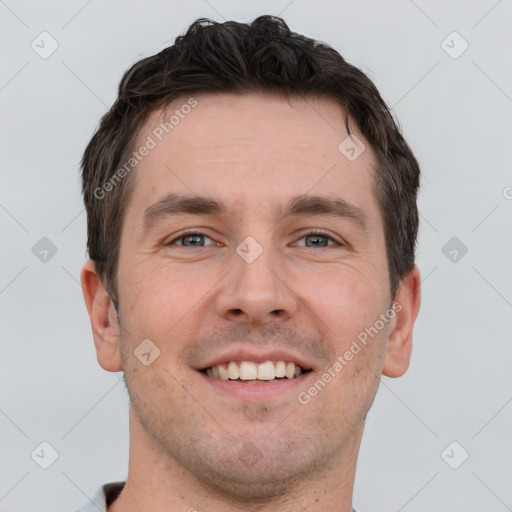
left=80, top=260, right=123, bottom=372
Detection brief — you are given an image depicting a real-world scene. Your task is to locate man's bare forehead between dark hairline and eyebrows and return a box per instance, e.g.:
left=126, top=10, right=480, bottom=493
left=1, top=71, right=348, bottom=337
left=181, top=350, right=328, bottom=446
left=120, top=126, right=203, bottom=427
left=128, top=93, right=378, bottom=230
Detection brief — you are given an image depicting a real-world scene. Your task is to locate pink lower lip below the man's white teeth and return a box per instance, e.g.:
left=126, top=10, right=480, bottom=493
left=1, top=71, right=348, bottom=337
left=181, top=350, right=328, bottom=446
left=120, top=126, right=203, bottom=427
left=198, top=372, right=313, bottom=400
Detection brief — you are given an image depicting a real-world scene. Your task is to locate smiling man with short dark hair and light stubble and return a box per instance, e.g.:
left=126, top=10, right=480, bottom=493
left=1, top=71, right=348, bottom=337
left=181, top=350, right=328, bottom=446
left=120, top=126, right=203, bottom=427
left=76, top=16, right=420, bottom=512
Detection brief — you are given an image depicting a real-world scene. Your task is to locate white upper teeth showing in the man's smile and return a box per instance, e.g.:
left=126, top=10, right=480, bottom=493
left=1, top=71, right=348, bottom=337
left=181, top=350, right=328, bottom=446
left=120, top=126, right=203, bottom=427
left=206, top=361, right=302, bottom=380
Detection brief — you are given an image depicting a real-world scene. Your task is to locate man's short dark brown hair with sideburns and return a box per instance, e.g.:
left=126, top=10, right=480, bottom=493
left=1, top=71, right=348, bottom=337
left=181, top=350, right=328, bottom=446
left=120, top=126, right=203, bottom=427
left=82, top=16, right=420, bottom=306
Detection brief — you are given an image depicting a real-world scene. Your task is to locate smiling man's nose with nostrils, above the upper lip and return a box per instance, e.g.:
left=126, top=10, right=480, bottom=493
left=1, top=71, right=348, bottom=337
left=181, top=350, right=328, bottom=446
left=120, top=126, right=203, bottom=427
left=216, top=241, right=298, bottom=325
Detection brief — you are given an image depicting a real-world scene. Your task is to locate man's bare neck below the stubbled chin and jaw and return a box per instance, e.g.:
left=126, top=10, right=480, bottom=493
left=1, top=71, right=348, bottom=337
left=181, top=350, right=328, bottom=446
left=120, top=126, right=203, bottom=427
left=108, top=406, right=364, bottom=512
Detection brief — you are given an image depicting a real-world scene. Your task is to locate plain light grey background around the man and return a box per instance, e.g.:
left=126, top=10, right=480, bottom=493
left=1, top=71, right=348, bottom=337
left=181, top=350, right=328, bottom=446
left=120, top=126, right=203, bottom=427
left=0, top=0, right=512, bottom=512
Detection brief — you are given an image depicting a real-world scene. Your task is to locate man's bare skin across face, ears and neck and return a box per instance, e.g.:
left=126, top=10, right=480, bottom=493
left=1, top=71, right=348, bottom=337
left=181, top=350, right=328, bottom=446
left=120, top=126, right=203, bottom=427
left=81, top=94, right=420, bottom=512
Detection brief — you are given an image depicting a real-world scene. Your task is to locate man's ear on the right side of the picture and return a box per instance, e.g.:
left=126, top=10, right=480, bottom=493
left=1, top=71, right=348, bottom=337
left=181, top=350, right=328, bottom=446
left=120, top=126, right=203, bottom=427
left=382, top=266, right=421, bottom=377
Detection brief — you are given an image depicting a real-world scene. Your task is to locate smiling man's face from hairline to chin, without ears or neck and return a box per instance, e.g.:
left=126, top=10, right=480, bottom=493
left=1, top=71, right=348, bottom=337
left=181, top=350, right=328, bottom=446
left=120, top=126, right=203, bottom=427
left=114, top=94, right=393, bottom=495
